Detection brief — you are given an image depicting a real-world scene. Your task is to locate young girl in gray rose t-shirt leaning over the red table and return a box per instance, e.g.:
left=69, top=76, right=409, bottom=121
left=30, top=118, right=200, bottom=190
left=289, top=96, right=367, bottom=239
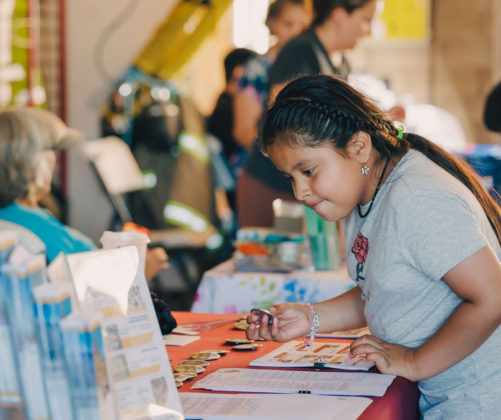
left=247, top=76, right=501, bottom=419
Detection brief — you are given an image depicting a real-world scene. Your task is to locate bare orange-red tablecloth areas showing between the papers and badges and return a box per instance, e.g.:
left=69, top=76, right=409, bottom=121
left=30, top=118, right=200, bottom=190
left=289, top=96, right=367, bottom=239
left=166, top=312, right=419, bottom=420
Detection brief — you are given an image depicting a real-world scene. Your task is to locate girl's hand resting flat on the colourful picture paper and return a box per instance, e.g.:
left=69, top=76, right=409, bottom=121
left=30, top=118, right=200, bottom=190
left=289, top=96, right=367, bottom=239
left=350, top=335, right=416, bottom=381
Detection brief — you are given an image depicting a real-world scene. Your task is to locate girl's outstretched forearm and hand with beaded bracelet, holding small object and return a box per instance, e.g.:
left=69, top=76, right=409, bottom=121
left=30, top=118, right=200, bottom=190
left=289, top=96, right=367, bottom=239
left=247, top=287, right=366, bottom=342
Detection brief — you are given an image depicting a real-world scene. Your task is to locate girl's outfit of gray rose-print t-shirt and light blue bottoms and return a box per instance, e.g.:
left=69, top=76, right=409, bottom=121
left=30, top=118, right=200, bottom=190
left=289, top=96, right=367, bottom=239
left=345, top=150, right=501, bottom=419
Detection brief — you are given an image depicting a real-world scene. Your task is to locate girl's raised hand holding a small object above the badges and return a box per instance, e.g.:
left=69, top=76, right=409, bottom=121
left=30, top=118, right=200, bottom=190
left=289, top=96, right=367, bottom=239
left=246, top=303, right=313, bottom=342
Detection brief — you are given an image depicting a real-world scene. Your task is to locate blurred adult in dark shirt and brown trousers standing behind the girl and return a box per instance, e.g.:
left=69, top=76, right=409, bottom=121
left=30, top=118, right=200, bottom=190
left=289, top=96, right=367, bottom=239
left=237, top=0, right=377, bottom=227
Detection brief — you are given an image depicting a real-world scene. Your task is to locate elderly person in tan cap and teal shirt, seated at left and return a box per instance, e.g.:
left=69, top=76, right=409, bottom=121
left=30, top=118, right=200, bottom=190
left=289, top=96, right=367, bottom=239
left=0, top=108, right=168, bottom=280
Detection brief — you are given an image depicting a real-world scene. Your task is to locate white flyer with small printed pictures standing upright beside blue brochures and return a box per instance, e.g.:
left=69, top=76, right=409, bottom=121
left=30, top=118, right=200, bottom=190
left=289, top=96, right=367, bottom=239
left=59, top=246, right=182, bottom=420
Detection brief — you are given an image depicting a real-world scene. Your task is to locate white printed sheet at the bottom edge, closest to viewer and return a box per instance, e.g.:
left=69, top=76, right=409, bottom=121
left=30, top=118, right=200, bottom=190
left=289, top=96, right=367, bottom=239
left=180, top=392, right=372, bottom=420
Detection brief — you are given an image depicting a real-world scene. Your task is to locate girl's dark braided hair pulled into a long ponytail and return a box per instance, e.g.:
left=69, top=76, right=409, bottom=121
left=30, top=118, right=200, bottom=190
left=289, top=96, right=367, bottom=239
left=260, top=75, right=501, bottom=243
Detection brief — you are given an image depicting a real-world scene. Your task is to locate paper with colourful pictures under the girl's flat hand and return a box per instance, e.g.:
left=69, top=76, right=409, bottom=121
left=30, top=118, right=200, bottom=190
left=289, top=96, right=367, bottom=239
left=250, top=341, right=374, bottom=370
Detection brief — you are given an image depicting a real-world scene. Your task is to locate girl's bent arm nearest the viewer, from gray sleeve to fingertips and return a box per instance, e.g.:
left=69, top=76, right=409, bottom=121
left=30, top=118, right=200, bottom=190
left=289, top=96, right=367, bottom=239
left=351, top=246, right=501, bottom=381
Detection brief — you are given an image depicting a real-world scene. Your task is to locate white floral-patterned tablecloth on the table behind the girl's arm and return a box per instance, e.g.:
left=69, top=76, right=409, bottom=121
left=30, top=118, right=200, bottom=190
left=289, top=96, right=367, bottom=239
left=191, top=260, right=354, bottom=313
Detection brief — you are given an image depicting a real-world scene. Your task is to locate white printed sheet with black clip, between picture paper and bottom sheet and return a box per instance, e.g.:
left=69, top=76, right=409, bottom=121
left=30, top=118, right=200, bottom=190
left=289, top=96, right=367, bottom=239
left=192, top=368, right=395, bottom=397
